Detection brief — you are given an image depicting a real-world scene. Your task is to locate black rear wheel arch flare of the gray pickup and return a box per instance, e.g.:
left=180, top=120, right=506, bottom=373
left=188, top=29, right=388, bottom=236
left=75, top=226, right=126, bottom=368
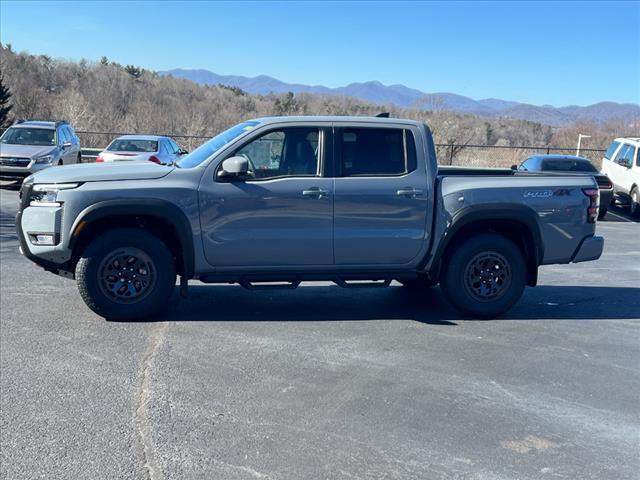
left=429, top=204, right=544, bottom=286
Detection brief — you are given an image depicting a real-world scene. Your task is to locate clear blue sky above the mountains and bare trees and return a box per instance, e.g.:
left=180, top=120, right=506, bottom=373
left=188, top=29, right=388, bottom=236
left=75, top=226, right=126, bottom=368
left=0, top=0, right=640, bottom=106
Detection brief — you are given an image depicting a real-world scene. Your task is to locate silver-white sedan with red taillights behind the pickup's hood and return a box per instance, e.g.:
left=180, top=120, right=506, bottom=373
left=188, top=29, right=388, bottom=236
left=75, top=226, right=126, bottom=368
left=96, top=135, right=187, bottom=165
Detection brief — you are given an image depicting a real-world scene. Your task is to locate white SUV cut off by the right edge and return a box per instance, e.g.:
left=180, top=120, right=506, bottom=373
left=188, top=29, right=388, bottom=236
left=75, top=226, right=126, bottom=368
left=602, top=137, right=640, bottom=218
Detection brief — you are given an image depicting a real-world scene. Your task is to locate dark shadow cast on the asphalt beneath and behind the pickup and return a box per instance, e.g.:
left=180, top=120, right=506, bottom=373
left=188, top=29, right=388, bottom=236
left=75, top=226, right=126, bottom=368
left=141, top=285, right=640, bottom=326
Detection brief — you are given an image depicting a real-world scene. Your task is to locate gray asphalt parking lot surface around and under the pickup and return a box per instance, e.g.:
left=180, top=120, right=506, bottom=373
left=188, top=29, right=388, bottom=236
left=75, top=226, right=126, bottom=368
left=0, top=185, right=640, bottom=480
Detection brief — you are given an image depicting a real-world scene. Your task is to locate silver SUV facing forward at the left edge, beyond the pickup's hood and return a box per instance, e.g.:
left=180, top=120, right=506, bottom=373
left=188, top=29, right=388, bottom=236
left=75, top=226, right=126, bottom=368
left=0, top=120, right=82, bottom=181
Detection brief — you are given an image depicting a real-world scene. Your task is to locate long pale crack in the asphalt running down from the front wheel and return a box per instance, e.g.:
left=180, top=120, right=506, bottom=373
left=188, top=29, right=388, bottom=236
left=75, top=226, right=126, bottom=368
left=133, top=322, right=167, bottom=480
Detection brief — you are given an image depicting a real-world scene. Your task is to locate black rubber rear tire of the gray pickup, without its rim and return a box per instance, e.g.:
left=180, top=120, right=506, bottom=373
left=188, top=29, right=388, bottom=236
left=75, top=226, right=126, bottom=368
left=440, top=234, right=527, bottom=318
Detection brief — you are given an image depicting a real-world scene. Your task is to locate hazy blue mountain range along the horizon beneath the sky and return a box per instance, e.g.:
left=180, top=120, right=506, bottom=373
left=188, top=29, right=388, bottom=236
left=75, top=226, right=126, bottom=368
left=158, top=68, right=640, bottom=126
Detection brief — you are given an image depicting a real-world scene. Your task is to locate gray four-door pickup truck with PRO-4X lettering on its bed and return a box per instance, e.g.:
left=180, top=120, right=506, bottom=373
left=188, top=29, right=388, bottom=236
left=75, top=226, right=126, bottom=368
left=17, top=117, right=604, bottom=319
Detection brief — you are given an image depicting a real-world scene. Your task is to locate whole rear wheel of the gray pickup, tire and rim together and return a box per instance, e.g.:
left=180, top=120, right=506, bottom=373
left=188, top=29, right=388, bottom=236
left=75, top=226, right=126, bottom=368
left=440, top=234, right=527, bottom=318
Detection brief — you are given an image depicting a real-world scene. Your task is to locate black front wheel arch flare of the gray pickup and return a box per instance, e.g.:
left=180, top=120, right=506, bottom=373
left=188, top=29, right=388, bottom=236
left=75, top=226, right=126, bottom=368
left=69, top=199, right=195, bottom=279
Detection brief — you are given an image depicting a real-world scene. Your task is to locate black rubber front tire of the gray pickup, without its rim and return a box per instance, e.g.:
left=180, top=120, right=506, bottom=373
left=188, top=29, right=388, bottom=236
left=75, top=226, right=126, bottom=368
left=75, top=228, right=176, bottom=320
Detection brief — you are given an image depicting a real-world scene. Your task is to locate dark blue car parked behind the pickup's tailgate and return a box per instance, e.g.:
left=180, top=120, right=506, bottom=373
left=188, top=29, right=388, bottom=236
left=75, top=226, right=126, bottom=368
left=518, top=155, right=613, bottom=219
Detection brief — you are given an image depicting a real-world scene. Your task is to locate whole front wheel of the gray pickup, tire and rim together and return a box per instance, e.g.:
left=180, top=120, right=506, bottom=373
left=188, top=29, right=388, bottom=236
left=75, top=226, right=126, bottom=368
left=75, top=228, right=176, bottom=320
